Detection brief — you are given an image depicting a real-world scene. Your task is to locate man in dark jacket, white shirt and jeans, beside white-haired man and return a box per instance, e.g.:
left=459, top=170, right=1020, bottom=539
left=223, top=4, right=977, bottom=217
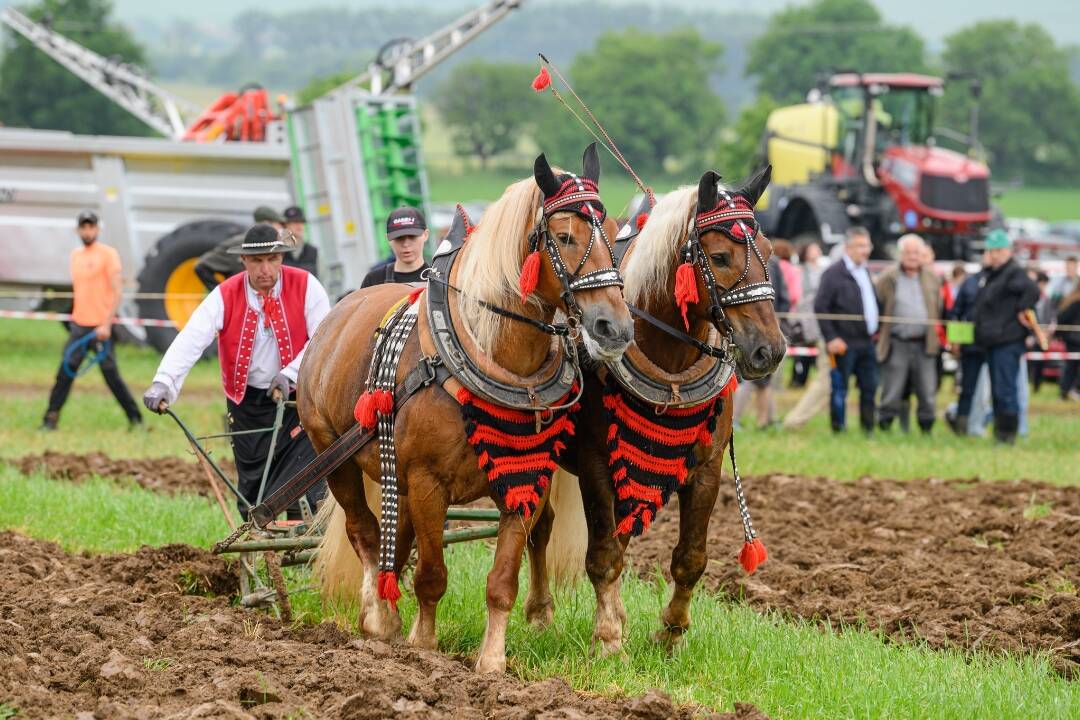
left=813, top=227, right=878, bottom=433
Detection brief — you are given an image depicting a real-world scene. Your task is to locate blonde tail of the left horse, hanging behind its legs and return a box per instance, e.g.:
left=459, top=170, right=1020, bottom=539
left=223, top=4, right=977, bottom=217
left=312, top=475, right=380, bottom=614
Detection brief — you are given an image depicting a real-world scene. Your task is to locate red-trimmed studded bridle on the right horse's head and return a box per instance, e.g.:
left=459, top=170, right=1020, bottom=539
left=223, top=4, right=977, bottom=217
left=683, top=184, right=777, bottom=338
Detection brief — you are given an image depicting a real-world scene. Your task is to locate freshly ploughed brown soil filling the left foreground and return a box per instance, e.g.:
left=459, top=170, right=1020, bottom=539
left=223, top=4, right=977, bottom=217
left=0, top=532, right=764, bottom=720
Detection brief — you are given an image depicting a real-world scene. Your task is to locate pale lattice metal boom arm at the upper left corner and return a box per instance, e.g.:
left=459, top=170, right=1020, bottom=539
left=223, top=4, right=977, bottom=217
left=0, top=8, right=199, bottom=139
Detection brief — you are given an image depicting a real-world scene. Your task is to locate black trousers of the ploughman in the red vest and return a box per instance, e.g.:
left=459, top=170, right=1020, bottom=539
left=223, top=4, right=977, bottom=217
left=226, top=385, right=326, bottom=520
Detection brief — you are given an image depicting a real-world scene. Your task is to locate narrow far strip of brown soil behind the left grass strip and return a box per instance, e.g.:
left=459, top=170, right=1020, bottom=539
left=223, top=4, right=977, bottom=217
left=8, top=450, right=235, bottom=495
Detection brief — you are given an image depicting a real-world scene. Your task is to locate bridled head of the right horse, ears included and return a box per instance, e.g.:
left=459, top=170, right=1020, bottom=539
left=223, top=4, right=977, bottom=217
left=686, top=165, right=786, bottom=379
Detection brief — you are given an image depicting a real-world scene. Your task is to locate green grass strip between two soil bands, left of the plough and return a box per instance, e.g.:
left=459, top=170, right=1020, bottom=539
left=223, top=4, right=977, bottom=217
left=0, top=463, right=228, bottom=553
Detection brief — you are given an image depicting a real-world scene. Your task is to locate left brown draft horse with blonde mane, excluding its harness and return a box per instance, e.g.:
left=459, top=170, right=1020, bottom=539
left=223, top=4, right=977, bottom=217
left=298, top=146, right=633, bottom=671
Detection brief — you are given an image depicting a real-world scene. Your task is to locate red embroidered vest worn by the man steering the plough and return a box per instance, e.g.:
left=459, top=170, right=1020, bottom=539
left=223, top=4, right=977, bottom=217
left=217, top=266, right=308, bottom=404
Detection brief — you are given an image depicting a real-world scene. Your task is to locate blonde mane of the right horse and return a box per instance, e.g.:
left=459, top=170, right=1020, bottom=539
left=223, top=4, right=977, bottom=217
left=622, top=186, right=698, bottom=305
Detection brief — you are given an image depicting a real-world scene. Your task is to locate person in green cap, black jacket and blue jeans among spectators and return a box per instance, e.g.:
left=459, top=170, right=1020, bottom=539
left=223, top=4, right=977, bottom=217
left=954, top=229, right=1039, bottom=444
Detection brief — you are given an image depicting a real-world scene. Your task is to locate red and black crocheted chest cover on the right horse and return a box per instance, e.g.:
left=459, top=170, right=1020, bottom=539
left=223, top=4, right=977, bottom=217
left=604, top=373, right=734, bottom=536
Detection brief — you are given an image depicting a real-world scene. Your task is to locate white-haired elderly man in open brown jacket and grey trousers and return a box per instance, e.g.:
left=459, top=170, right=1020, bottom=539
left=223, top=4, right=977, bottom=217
left=877, top=234, right=942, bottom=433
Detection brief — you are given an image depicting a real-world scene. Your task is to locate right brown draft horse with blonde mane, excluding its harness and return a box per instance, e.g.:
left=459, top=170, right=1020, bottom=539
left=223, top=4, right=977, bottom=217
left=534, top=168, right=786, bottom=654
